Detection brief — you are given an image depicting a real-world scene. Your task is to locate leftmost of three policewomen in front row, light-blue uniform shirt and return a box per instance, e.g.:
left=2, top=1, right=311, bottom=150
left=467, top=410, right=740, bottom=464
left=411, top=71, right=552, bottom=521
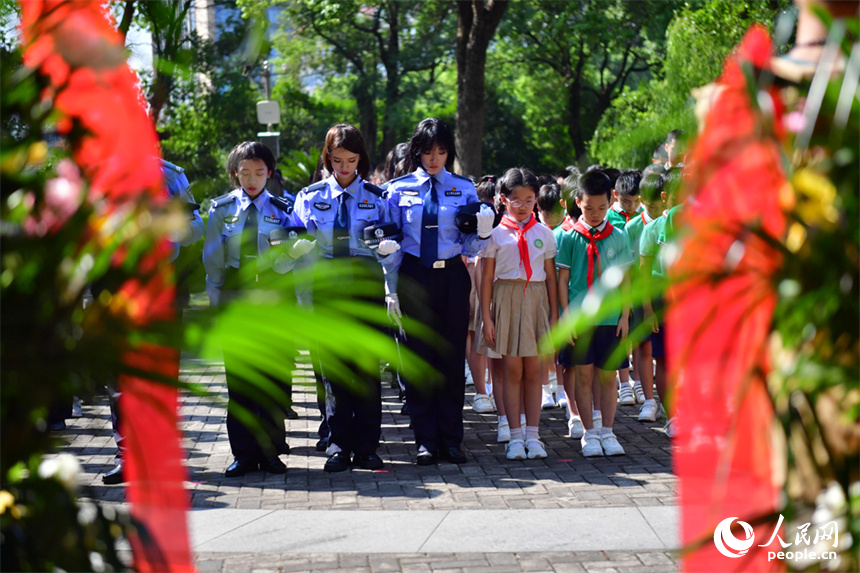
left=203, top=142, right=308, bottom=477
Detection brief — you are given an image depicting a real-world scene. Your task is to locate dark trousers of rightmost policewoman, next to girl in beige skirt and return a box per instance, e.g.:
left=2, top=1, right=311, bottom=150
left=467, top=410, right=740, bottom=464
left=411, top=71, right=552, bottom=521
left=398, top=255, right=472, bottom=452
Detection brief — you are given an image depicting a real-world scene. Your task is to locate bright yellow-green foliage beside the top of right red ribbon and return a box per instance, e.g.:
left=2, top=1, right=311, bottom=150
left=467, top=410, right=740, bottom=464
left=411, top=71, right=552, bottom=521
left=589, top=0, right=789, bottom=168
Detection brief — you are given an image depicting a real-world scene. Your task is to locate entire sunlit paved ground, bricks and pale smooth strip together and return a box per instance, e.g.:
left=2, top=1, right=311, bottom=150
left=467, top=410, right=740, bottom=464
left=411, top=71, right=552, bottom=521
left=64, top=355, right=679, bottom=573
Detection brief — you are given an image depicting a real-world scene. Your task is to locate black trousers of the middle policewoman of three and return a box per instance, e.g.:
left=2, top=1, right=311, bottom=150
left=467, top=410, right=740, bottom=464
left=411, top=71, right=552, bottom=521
left=314, top=256, right=385, bottom=455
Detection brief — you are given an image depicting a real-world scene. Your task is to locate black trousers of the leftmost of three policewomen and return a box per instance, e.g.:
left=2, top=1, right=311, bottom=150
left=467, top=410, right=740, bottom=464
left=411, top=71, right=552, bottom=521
left=221, top=291, right=296, bottom=463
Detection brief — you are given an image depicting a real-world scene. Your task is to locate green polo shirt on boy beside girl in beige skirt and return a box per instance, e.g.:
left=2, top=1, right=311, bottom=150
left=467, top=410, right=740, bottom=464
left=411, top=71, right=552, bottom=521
left=555, top=220, right=633, bottom=326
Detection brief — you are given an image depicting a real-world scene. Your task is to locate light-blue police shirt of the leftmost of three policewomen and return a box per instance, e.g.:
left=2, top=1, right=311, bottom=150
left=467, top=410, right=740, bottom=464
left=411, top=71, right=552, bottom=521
left=203, top=189, right=302, bottom=305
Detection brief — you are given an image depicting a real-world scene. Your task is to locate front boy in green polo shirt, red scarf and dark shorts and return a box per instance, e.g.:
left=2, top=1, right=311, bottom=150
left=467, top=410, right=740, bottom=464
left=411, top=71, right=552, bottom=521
left=556, top=171, right=632, bottom=457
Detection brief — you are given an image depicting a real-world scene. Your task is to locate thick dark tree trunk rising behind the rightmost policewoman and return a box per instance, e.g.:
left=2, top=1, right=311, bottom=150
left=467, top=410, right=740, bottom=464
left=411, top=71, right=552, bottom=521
left=454, top=0, right=508, bottom=178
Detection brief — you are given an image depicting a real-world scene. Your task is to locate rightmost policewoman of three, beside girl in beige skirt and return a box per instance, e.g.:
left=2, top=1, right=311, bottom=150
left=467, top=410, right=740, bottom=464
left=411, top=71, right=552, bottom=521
left=386, top=118, right=495, bottom=465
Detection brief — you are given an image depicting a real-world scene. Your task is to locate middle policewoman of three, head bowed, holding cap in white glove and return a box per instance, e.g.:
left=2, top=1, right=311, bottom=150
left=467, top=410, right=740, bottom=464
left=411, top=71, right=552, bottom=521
left=296, top=124, right=400, bottom=472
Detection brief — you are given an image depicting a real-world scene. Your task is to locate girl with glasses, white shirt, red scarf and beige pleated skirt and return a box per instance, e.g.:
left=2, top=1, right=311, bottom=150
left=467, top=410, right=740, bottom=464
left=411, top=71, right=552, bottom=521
left=481, top=168, right=558, bottom=460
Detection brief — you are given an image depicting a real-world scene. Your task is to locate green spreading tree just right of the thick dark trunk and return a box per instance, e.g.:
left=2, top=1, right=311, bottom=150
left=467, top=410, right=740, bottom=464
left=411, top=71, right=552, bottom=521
left=500, top=0, right=675, bottom=163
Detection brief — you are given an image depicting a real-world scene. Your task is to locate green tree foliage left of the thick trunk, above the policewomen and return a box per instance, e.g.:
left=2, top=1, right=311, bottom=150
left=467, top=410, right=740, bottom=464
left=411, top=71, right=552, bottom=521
left=258, top=0, right=453, bottom=160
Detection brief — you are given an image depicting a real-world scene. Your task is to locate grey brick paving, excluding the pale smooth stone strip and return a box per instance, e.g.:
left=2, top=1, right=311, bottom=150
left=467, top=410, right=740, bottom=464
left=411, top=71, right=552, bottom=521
left=64, top=350, right=676, bottom=573
